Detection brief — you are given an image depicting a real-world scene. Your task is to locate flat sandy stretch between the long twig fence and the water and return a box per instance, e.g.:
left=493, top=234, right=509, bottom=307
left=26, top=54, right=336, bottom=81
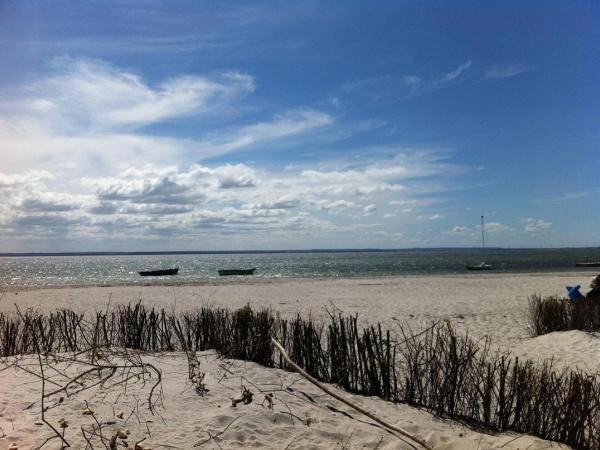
left=0, top=271, right=595, bottom=348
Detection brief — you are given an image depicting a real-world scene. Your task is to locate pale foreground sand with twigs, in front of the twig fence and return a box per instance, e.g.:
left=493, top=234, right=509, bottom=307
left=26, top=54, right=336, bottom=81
left=0, top=352, right=567, bottom=450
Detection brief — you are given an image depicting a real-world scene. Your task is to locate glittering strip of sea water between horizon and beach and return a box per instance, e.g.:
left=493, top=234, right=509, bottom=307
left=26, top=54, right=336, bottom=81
left=0, top=248, right=600, bottom=288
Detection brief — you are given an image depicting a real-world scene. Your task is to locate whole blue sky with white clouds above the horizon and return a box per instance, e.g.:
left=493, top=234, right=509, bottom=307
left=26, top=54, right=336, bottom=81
left=0, top=0, right=600, bottom=252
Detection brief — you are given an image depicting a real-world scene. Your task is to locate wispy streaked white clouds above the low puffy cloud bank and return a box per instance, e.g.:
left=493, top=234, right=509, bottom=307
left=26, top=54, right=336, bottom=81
left=0, top=58, right=334, bottom=179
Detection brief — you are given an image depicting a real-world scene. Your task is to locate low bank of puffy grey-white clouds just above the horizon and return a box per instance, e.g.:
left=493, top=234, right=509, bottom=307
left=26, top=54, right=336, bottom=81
left=0, top=146, right=460, bottom=245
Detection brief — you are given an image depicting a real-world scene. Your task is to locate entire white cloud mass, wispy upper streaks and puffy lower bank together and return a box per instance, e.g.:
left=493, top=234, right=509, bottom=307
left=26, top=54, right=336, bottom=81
left=0, top=59, right=468, bottom=248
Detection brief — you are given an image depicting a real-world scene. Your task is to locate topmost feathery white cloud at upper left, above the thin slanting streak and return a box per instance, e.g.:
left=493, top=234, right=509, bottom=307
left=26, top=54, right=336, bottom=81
left=13, top=58, right=254, bottom=130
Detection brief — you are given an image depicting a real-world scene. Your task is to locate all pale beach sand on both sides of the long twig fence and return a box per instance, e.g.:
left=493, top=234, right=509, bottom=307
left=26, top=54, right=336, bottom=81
left=0, top=272, right=600, bottom=450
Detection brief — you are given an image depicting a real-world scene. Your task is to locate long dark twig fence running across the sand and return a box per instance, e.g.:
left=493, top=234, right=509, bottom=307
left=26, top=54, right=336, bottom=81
left=0, top=304, right=600, bottom=449
